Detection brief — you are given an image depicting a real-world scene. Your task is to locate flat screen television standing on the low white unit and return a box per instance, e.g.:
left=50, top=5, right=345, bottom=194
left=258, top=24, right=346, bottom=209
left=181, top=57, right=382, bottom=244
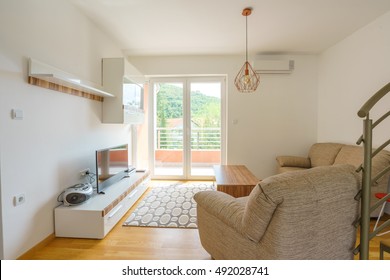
left=96, top=144, right=132, bottom=194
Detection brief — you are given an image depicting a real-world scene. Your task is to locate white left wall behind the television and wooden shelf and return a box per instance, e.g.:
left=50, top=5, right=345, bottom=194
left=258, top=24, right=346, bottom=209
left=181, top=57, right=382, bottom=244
left=0, top=0, right=130, bottom=259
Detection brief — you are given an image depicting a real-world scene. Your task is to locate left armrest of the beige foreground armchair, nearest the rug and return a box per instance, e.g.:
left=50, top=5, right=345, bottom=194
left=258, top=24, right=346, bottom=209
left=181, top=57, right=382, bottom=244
left=194, top=191, right=247, bottom=233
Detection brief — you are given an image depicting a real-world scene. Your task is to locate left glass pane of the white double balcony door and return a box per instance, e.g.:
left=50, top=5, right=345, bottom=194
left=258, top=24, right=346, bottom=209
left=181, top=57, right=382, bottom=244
left=153, top=82, right=185, bottom=178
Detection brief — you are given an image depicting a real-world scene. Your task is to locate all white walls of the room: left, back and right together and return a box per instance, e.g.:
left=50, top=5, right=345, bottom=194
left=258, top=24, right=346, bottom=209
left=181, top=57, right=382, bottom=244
left=0, top=0, right=390, bottom=259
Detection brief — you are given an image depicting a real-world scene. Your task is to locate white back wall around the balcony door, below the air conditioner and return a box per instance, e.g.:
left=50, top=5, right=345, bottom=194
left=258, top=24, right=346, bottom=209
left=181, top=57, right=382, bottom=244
left=129, top=55, right=318, bottom=178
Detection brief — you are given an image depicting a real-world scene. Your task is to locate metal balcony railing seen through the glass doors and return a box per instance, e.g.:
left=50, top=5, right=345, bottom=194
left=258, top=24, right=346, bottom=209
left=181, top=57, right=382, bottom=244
left=156, top=127, right=221, bottom=150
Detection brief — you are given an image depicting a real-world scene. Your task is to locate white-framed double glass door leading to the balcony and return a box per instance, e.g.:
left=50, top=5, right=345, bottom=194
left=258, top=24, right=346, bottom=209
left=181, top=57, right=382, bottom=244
left=150, top=77, right=226, bottom=179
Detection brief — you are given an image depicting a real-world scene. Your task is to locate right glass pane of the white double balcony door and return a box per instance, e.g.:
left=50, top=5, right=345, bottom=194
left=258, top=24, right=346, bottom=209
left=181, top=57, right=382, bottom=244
left=189, top=81, right=222, bottom=178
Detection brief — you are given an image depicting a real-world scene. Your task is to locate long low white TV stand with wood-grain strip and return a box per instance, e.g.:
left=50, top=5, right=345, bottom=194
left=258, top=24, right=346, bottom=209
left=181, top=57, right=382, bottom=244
left=54, top=171, right=149, bottom=239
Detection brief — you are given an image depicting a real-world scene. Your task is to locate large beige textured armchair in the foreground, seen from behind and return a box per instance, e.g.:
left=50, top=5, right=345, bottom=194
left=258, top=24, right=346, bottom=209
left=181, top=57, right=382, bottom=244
left=194, top=165, right=360, bottom=260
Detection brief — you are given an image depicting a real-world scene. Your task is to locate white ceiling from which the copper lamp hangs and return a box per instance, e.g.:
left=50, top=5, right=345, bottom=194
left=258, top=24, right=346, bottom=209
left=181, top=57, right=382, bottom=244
left=68, top=0, right=390, bottom=56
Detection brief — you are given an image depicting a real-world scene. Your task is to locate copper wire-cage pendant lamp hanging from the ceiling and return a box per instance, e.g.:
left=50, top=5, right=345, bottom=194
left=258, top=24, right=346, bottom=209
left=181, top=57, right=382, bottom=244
left=234, top=8, right=260, bottom=93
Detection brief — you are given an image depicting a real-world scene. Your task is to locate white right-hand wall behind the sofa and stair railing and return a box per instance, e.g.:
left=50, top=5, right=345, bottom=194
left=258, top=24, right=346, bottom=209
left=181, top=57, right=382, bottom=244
left=318, top=12, right=390, bottom=146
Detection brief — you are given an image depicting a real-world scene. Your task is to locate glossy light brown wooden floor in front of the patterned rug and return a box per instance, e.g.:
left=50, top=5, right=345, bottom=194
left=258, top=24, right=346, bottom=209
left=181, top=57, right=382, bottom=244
left=20, top=182, right=390, bottom=260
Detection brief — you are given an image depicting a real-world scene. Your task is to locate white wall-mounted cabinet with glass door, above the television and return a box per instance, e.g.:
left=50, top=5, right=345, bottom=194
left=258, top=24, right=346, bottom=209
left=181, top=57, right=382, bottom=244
left=102, top=58, right=145, bottom=124
